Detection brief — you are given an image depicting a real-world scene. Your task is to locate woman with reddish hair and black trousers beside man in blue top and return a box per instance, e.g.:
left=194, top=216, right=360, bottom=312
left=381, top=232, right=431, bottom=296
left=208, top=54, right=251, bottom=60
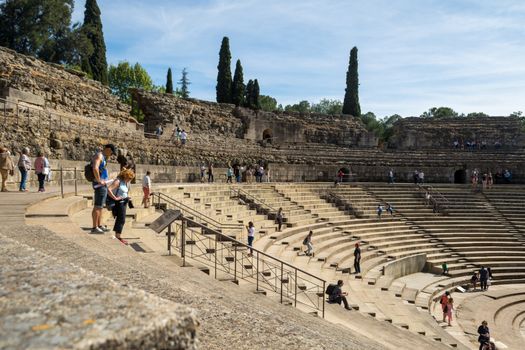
left=107, top=169, right=135, bottom=245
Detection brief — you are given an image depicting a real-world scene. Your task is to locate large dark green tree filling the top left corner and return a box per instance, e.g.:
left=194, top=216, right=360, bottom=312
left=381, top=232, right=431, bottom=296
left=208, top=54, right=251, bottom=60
left=0, top=0, right=85, bottom=64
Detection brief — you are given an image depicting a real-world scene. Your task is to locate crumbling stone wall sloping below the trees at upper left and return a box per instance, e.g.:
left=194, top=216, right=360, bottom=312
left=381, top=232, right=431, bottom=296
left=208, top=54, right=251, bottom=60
left=0, top=47, right=132, bottom=121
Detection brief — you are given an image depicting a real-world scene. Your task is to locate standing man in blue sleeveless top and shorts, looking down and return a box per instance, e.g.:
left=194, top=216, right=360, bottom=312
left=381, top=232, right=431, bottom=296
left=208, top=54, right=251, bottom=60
left=91, top=144, right=116, bottom=233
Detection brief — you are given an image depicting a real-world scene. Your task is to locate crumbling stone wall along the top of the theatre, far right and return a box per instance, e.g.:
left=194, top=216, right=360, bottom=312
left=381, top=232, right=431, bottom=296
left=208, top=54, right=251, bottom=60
left=390, top=117, right=525, bottom=149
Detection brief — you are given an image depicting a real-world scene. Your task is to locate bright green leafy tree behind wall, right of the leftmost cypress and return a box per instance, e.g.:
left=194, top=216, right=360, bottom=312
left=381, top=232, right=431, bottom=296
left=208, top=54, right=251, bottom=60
left=107, top=61, right=154, bottom=120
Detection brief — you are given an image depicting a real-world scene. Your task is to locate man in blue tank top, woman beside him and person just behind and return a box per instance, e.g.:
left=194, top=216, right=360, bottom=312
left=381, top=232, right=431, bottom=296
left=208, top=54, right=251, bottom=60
left=90, top=144, right=151, bottom=245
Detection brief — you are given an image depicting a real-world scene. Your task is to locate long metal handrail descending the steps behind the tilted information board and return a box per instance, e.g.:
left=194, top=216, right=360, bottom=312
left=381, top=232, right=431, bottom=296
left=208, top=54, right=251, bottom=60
left=158, top=205, right=326, bottom=318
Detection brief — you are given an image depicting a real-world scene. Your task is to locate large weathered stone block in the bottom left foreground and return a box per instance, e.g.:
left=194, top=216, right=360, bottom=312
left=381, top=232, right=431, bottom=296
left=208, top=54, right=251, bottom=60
left=0, top=235, right=198, bottom=349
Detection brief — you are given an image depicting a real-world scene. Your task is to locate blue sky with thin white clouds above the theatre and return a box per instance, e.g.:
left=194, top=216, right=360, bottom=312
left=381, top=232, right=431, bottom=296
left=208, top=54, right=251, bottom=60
left=74, top=0, right=525, bottom=117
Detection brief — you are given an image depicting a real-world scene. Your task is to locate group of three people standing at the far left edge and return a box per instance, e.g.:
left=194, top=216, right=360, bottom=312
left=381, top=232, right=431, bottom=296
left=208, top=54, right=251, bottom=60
left=0, top=147, right=51, bottom=192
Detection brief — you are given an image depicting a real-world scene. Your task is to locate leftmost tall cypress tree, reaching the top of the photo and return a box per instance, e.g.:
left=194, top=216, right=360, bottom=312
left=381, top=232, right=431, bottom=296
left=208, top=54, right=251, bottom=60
left=84, top=0, right=108, bottom=85
